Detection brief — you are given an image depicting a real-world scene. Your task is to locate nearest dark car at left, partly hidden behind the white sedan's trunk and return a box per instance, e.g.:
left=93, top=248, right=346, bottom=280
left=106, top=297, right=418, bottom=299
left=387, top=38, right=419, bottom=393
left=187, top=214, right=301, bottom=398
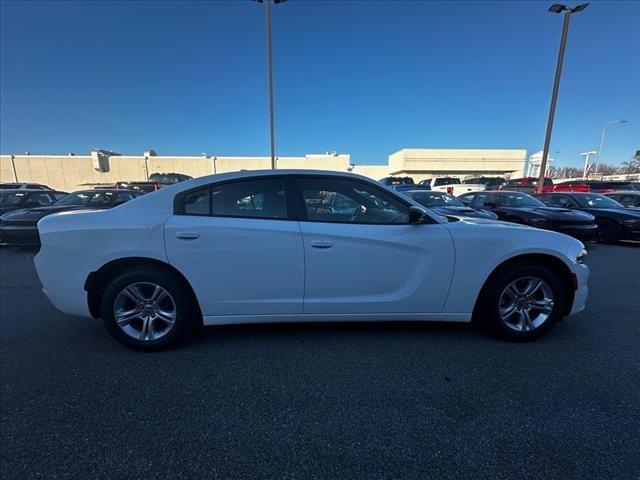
left=0, top=189, right=143, bottom=245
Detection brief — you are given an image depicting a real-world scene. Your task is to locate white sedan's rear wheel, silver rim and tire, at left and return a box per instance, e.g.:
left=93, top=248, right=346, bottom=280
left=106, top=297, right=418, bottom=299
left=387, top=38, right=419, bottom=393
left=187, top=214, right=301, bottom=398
left=101, top=267, right=196, bottom=351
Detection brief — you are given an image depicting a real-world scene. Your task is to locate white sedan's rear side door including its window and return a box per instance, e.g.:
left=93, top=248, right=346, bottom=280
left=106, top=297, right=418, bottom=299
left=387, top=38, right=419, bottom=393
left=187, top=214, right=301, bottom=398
left=165, top=176, right=304, bottom=322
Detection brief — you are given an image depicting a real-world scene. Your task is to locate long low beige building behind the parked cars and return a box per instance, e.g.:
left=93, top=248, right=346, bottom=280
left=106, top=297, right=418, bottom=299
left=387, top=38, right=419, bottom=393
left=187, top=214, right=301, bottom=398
left=0, top=149, right=527, bottom=191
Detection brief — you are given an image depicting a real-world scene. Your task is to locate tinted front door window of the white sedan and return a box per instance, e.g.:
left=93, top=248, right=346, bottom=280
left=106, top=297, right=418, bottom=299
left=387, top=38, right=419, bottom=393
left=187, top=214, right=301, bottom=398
left=300, top=178, right=409, bottom=224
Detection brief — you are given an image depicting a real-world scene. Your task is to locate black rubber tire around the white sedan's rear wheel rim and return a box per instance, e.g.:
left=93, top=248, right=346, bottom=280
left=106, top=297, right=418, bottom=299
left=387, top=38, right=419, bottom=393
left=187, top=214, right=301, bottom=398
left=100, top=266, right=198, bottom=352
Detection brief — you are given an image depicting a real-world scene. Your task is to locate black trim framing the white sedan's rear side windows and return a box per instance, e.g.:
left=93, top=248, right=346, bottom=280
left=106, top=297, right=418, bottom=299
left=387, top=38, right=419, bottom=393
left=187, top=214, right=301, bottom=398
left=173, top=174, right=298, bottom=221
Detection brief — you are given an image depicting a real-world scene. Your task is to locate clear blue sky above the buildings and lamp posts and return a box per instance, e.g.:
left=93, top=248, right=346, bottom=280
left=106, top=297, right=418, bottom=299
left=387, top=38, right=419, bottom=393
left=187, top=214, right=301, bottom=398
left=0, top=0, right=640, bottom=166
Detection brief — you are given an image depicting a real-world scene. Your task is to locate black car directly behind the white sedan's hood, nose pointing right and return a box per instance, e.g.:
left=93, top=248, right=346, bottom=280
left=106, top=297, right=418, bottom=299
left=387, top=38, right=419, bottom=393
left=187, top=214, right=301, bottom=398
left=458, top=190, right=598, bottom=240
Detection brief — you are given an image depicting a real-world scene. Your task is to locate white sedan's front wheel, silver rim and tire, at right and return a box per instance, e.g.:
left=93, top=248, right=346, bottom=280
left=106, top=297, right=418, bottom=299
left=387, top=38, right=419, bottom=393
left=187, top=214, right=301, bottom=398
left=481, top=263, right=565, bottom=341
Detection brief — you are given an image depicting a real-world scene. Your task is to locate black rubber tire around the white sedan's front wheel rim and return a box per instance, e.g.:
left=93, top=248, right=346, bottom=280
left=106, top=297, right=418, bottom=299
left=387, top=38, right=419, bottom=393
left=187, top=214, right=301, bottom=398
left=475, top=262, right=566, bottom=342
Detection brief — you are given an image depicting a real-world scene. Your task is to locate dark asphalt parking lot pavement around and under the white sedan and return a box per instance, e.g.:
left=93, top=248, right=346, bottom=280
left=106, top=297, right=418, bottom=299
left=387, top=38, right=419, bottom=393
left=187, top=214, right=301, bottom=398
left=0, top=244, right=640, bottom=479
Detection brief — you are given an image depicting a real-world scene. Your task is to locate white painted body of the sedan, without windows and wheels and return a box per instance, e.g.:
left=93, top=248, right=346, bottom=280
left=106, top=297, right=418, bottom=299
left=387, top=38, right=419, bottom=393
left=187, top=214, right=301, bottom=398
left=35, top=170, right=588, bottom=324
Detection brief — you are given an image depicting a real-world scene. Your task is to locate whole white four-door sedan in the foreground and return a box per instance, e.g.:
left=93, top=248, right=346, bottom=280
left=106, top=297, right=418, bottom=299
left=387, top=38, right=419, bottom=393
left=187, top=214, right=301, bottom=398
left=35, top=170, right=589, bottom=350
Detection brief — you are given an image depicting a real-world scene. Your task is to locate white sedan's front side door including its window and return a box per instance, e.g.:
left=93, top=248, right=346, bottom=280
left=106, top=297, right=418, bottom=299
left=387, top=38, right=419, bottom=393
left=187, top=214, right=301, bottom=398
left=296, top=176, right=454, bottom=319
